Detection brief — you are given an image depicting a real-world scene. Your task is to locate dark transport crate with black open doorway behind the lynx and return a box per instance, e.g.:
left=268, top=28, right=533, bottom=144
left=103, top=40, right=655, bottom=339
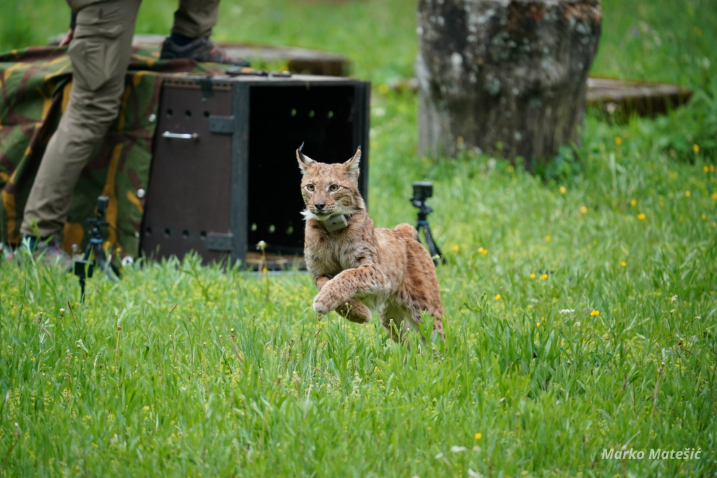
left=140, top=74, right=370, bottom=269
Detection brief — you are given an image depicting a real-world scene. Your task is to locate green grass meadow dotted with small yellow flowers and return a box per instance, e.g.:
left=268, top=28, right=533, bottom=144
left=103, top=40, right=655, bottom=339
left=0, top=0, right=717, bottom=477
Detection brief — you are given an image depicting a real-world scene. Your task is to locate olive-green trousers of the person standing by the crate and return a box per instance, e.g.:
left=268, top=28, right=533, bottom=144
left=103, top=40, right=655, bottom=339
left=21, top=0, right=219, bottom=240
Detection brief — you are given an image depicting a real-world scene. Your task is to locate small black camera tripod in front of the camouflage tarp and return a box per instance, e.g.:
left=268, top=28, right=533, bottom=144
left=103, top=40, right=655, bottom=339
left=74, top=196, right=120, bottom=302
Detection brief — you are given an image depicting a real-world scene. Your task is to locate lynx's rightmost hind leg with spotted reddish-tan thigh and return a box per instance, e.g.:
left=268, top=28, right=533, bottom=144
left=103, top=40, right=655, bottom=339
left=400, top=235, right=446, bottom=339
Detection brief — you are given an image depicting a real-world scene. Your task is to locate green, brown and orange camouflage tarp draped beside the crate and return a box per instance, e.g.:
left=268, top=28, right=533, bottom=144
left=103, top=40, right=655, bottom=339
left=0, top=46, right=227, bottom=257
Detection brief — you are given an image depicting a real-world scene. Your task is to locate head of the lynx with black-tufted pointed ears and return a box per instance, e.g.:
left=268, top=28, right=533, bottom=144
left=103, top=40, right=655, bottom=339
left=296, top=144, right=366, bottom=221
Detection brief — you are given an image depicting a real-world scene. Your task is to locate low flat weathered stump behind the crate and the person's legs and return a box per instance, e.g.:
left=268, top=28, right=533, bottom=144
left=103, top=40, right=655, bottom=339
left=48, top=33, right=351, bottom=76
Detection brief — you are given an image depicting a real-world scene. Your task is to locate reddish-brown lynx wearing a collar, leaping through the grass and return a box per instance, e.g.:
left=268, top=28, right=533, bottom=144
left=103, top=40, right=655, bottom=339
left=296, top=144, right=444, bottom=341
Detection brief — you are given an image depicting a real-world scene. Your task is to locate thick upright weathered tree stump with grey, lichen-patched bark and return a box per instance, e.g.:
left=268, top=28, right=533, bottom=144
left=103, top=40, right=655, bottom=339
left=416, top=0, right=602, bottom=170
